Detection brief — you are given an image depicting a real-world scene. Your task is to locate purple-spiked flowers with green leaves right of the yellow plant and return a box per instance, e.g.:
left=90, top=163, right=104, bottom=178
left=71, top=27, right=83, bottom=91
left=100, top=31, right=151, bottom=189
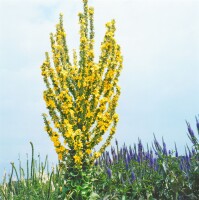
left=92, top=118, right=199, bottom=199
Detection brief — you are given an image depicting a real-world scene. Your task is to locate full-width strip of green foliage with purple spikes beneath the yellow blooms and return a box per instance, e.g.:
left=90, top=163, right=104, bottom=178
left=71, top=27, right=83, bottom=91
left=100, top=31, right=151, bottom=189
left=0, top=116, right=199, bottom=200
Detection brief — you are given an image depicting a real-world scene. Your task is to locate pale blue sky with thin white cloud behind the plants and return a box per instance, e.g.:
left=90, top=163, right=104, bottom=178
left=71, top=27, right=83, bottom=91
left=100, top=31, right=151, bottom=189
left=0, top=0, right=199, bottom=176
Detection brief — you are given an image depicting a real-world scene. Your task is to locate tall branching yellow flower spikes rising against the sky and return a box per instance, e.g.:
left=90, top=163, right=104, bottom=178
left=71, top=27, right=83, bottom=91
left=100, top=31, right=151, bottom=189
left=41, top=0, right=122, bottom=172
